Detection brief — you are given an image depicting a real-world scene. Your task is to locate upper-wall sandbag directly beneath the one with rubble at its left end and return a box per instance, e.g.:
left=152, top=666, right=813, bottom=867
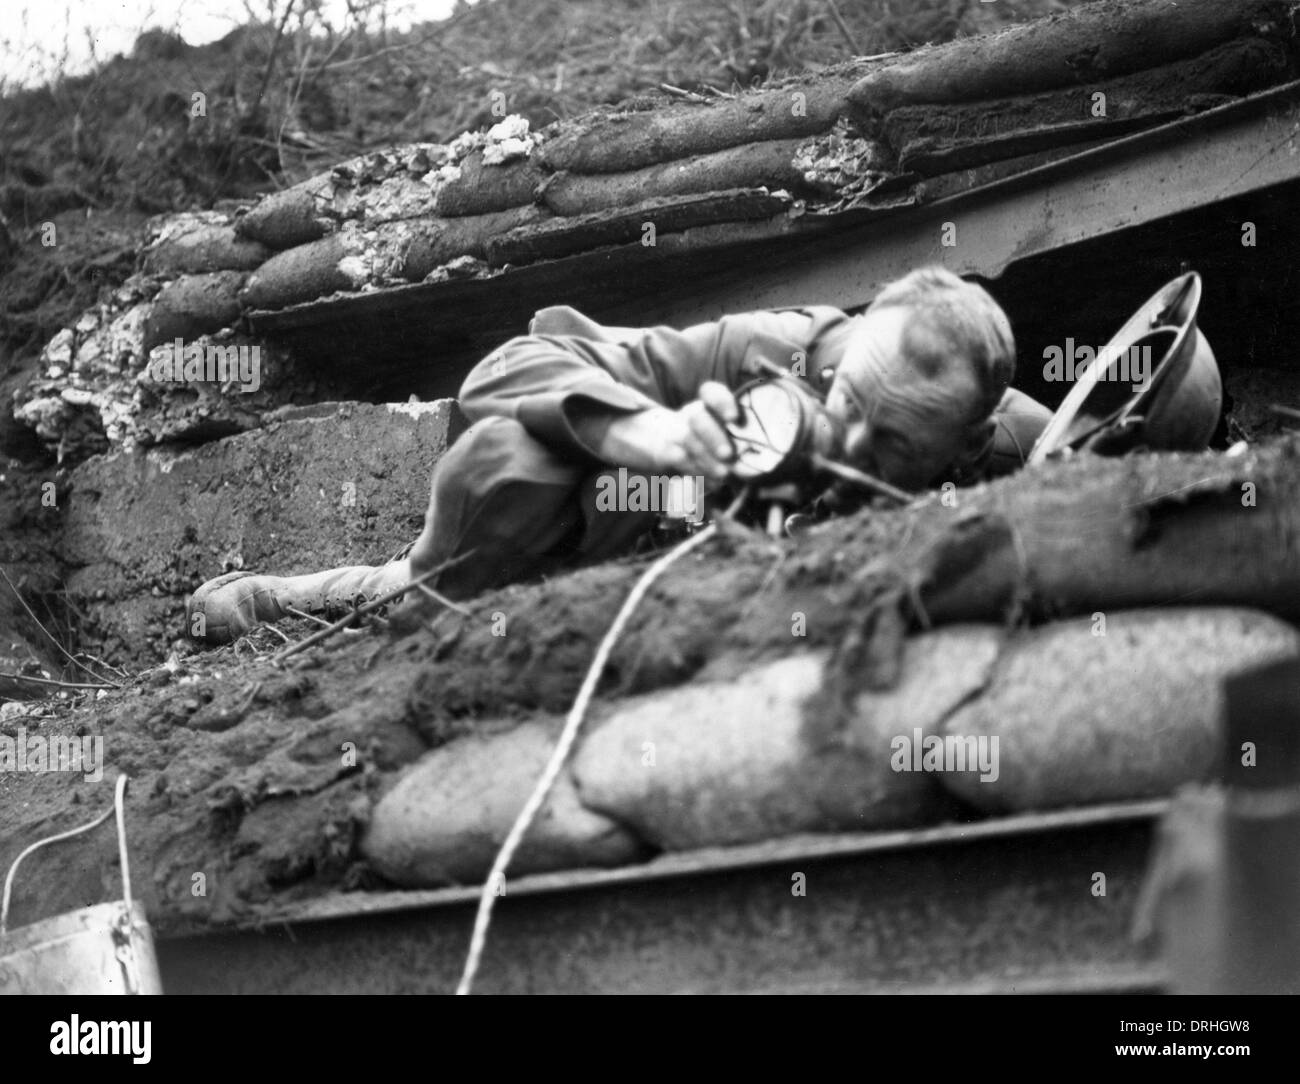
left=542, top=139, right=803, bottom=214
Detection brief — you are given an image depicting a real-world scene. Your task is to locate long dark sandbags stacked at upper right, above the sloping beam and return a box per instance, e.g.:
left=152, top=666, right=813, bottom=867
left=848, top=0, right=1296, bottom=174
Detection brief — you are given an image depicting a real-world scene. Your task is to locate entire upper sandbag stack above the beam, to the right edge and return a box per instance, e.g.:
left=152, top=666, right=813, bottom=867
left=228, top=0, right=1295, bottom=309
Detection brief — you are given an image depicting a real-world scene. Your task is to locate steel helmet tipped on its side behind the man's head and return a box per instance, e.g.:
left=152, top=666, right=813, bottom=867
left=1028, top=272, right=1223, bottom=463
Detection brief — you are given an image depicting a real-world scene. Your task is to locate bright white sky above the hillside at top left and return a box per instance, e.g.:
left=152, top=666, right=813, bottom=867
left=0, top=0, right=467, bottom=86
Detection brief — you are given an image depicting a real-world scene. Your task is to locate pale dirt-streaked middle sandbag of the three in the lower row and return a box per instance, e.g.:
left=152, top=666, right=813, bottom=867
left=572, top=626, right=1000, bottom=850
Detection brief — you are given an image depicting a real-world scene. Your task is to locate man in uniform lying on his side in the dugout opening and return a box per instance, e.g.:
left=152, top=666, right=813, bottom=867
left=189, top=268, right=1052, bottom=643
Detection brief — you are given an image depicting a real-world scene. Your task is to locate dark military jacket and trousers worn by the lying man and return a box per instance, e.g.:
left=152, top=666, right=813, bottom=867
left=410, top=305, right=1050, bottom=598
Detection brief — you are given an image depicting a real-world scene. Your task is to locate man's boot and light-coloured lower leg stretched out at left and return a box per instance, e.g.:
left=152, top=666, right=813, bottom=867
left=186, top=560, right=411, bottom=643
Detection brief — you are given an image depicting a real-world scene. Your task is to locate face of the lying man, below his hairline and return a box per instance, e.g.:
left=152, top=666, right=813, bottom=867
left=827, top=307, right=979, bottom=490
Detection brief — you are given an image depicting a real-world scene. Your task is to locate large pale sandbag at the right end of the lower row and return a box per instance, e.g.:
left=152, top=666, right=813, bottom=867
left=936, top=607, right=1300, bottom=812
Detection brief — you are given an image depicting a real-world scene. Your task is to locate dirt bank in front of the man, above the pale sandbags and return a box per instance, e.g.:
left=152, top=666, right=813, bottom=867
left=0, top=441, right=1300, bottom=931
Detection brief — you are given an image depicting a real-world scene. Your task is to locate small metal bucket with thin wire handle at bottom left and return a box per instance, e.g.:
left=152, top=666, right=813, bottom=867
left=0, top=775, right=163, bottom=994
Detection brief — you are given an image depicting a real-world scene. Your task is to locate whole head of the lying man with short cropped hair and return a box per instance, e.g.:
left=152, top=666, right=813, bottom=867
left=827, top=268, right=1015, bottom=490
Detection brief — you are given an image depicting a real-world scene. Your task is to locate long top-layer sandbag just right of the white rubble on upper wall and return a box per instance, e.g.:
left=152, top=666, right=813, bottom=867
left=538, top=75, right=853, bottom=173
